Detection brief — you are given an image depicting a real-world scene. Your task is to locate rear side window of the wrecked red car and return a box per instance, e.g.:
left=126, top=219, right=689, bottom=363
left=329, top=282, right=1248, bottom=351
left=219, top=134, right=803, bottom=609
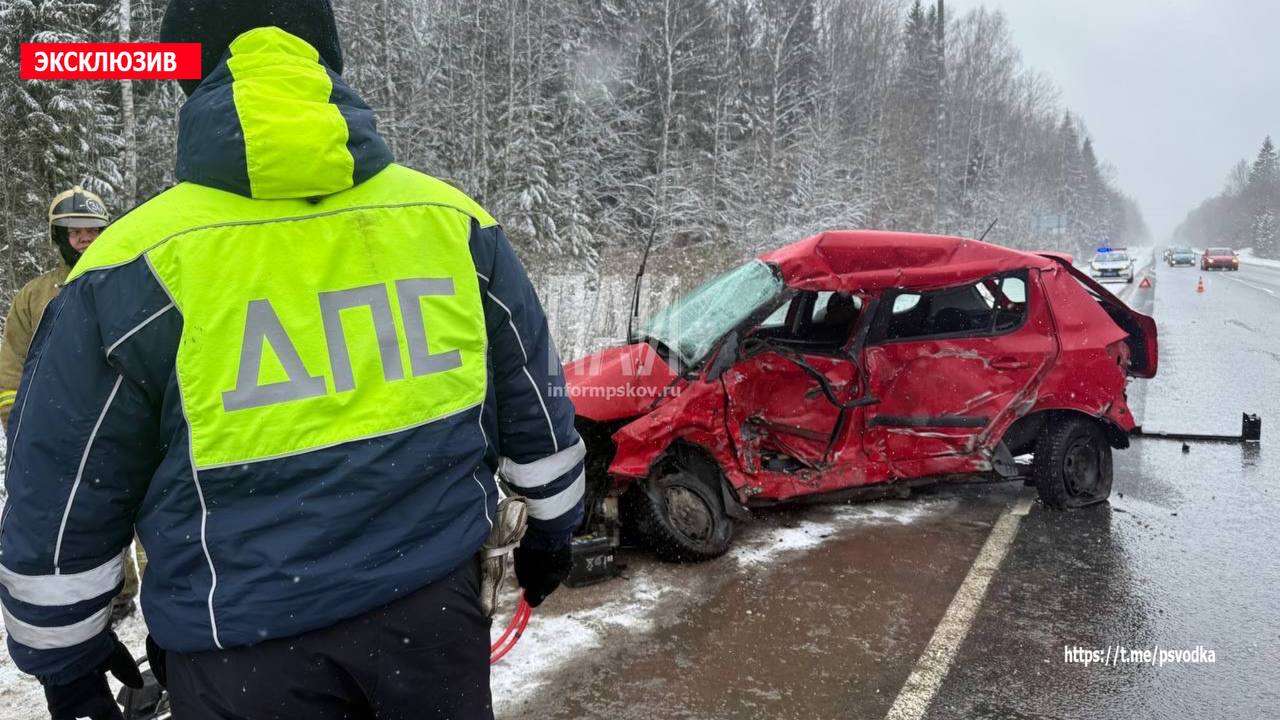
left=873, top=273, right=1027, bottom=342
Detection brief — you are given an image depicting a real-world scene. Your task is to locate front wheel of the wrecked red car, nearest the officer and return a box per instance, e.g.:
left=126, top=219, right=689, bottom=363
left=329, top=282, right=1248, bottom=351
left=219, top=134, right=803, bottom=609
left=623, top=453, right=733, bottom=562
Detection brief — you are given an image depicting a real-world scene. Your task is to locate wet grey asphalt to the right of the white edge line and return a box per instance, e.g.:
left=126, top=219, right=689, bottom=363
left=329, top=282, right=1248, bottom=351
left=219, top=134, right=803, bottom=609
left=927, top=268, right=1280, bottom=719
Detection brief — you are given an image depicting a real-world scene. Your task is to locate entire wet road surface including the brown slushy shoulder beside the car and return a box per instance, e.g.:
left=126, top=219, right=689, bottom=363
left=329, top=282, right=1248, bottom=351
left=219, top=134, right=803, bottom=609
left=506, top=260, right=1280, bottom=720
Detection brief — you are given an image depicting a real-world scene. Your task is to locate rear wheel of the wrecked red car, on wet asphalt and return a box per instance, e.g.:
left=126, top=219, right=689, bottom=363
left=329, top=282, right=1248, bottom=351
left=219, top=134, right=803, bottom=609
left=1032, top=416, right=1112, bottom=510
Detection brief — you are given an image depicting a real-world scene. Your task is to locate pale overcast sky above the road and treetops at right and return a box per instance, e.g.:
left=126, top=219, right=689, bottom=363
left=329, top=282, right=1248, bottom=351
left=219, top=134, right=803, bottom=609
left=947, top=0, right=1280, bottom=242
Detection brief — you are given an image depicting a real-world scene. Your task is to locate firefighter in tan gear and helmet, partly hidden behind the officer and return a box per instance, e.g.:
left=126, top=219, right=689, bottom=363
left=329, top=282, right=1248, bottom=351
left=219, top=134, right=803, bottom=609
left=0, top=186, right=146, bottom=623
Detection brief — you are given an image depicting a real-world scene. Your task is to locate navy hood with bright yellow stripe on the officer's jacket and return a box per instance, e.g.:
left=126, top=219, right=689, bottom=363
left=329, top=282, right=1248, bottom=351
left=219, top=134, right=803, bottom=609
left=177, top=27, right=392, bottom=199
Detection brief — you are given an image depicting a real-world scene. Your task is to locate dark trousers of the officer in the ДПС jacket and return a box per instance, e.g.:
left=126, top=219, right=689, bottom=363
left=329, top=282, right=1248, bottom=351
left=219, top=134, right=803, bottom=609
left=165, top=562, right=493, bottom=720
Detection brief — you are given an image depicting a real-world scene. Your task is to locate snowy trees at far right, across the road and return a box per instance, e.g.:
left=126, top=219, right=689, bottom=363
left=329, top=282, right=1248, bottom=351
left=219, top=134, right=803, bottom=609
left=1174, top=136, right=1280, bottom=259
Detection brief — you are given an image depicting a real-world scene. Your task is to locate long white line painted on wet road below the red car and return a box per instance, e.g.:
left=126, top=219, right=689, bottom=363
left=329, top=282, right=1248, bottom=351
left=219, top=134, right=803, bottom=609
left=884, top=497, right=1032, bottom=720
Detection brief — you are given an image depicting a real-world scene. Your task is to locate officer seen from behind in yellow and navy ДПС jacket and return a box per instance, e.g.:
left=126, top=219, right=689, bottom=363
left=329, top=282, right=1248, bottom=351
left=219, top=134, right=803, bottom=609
left=0, top=0, right=584, bottom=719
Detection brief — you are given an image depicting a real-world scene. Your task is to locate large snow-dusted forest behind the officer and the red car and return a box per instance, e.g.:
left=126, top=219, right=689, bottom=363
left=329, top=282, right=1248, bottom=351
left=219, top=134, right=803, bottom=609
left=0, top=0, right=1152, bottom=301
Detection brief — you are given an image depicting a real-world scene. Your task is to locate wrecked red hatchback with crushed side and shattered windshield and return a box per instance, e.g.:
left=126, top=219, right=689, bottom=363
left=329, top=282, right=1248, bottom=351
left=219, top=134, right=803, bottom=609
left=566, top=232, right=1157, bottom=560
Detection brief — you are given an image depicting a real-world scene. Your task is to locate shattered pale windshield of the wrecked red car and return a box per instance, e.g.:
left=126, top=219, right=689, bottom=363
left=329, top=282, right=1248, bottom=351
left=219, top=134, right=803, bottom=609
left=640, top=260, right=783, bottom=366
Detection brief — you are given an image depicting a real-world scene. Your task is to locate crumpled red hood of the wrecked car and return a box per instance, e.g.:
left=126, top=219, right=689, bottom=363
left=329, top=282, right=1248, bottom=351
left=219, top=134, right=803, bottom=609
left=564, top=342, right=684, bottom=421
